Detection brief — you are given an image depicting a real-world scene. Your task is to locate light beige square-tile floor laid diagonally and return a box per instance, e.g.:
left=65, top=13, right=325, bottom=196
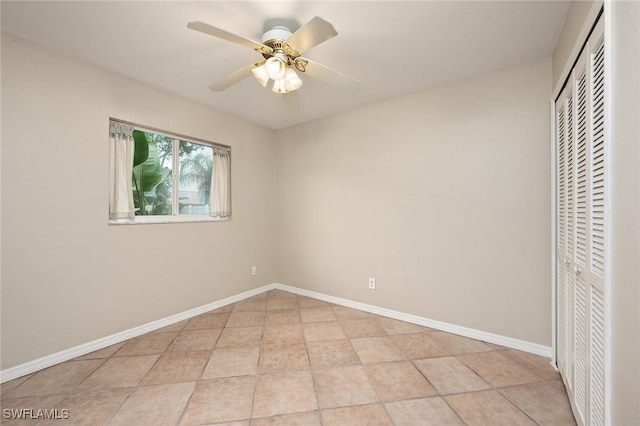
left=0, top=290, right=575, bottom=426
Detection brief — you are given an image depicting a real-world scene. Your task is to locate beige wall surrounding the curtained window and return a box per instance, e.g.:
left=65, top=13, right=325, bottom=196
left=2, top=36, right=275, bottom=369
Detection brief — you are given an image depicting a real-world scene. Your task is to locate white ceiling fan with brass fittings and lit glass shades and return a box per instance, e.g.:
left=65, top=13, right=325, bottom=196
left=187, top=16, right=362, bottom=93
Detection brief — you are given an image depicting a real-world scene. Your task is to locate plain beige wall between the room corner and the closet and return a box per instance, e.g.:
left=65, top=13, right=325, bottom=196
left=276, top=58, right=551, bottom=346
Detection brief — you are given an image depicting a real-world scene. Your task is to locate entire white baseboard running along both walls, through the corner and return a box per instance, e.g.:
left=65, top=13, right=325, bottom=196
left=0, top=283, right=551, bottom=383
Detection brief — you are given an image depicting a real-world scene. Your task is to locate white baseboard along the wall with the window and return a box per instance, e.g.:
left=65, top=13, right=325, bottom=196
left=0, top=284, right=276, bottom=383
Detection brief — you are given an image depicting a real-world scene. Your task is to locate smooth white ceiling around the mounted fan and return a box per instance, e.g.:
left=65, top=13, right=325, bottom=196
left=1, top=1, right=569, bottom=129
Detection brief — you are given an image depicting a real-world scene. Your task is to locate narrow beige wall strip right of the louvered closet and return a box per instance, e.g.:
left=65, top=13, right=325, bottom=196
left=605, top=1, right=640, bottom=425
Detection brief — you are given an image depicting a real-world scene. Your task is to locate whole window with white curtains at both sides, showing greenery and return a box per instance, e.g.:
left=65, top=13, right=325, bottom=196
left=109, top=119, right=231, bottom=224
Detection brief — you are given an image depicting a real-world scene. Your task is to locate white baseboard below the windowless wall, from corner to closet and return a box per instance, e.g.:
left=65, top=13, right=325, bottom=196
left=274, top=283, right=551, bottom=358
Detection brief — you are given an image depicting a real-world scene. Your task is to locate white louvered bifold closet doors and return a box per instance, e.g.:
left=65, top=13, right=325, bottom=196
left=555, top=14, right=606, bottom=425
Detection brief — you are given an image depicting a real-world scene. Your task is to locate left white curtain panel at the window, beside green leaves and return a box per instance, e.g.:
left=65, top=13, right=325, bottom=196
left=109, top=121, right=135, bottom=219
